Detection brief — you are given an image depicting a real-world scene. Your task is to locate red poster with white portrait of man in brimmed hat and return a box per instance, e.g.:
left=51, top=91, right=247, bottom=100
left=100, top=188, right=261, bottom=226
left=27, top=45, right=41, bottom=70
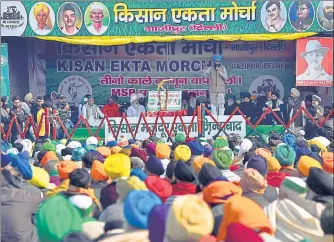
left=296, top=38, right=333, bottom=87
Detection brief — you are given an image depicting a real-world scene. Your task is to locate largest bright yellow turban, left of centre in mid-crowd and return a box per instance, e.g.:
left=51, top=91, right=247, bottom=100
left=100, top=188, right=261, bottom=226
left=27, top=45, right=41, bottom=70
left=104, top=154, right=131, bottom=179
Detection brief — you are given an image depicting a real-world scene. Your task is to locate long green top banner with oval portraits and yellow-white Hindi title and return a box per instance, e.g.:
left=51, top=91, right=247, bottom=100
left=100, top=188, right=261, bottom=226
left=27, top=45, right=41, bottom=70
left=1, top=0, right=333, bottom=36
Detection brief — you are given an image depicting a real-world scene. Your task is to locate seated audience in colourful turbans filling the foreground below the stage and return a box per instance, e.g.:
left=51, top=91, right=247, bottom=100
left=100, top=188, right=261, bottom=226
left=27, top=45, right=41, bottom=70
left=1, top=131, right=334, bottom=242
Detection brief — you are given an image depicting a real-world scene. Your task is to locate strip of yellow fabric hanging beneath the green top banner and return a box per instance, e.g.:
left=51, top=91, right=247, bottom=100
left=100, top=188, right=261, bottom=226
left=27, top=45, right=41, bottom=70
left=36, top=32, right=317, bottom=46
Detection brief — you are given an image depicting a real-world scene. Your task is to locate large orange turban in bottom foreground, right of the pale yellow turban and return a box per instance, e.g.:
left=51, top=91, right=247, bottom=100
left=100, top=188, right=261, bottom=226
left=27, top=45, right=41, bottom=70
left=217, top=196, right=274, bottom=241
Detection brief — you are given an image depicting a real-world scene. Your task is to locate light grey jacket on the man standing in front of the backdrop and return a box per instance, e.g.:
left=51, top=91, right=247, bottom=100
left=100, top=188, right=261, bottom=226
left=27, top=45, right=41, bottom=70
left=205, top=66, right=228, bottom=93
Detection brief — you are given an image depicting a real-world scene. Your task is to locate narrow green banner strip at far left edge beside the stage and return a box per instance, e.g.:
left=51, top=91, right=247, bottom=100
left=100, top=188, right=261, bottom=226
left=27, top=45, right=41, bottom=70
left=1, top=43, right=10, bottom=97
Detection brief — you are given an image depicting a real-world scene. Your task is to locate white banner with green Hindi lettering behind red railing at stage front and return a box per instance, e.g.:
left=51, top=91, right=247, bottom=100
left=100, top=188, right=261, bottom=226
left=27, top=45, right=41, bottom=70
left=105, top=115, right=246, bottom=140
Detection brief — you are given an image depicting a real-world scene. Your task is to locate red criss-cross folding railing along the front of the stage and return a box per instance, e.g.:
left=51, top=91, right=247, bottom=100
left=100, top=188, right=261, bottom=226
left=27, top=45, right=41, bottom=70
left=1, top=104, right=334, bottom=142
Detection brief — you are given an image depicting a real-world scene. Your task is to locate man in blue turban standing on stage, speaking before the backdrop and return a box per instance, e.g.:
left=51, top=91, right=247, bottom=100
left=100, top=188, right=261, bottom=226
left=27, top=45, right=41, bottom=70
left=204, top=55, right=228, bottom=116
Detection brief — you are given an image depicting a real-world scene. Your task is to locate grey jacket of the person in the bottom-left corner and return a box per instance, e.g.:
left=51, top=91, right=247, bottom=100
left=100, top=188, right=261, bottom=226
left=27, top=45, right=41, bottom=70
left=1, top=170, right=43, bottom=242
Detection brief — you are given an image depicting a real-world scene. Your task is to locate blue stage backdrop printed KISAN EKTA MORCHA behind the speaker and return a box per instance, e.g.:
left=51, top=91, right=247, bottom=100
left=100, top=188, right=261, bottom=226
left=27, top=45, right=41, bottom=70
left=41, top=41, right=295, bottom=106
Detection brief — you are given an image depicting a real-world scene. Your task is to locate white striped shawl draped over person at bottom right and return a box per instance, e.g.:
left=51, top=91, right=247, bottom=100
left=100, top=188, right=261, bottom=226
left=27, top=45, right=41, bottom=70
left=264, top=199, right=324, bottom=242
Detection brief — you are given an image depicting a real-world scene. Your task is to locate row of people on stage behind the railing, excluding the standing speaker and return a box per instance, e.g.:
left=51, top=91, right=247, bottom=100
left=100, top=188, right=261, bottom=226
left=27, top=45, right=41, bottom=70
left=0, top=88, right=333, bottom=145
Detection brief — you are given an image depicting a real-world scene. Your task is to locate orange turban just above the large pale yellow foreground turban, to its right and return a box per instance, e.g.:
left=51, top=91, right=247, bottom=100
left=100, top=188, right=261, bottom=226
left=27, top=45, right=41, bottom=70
left=203, top=181, right=242, bottom=204
